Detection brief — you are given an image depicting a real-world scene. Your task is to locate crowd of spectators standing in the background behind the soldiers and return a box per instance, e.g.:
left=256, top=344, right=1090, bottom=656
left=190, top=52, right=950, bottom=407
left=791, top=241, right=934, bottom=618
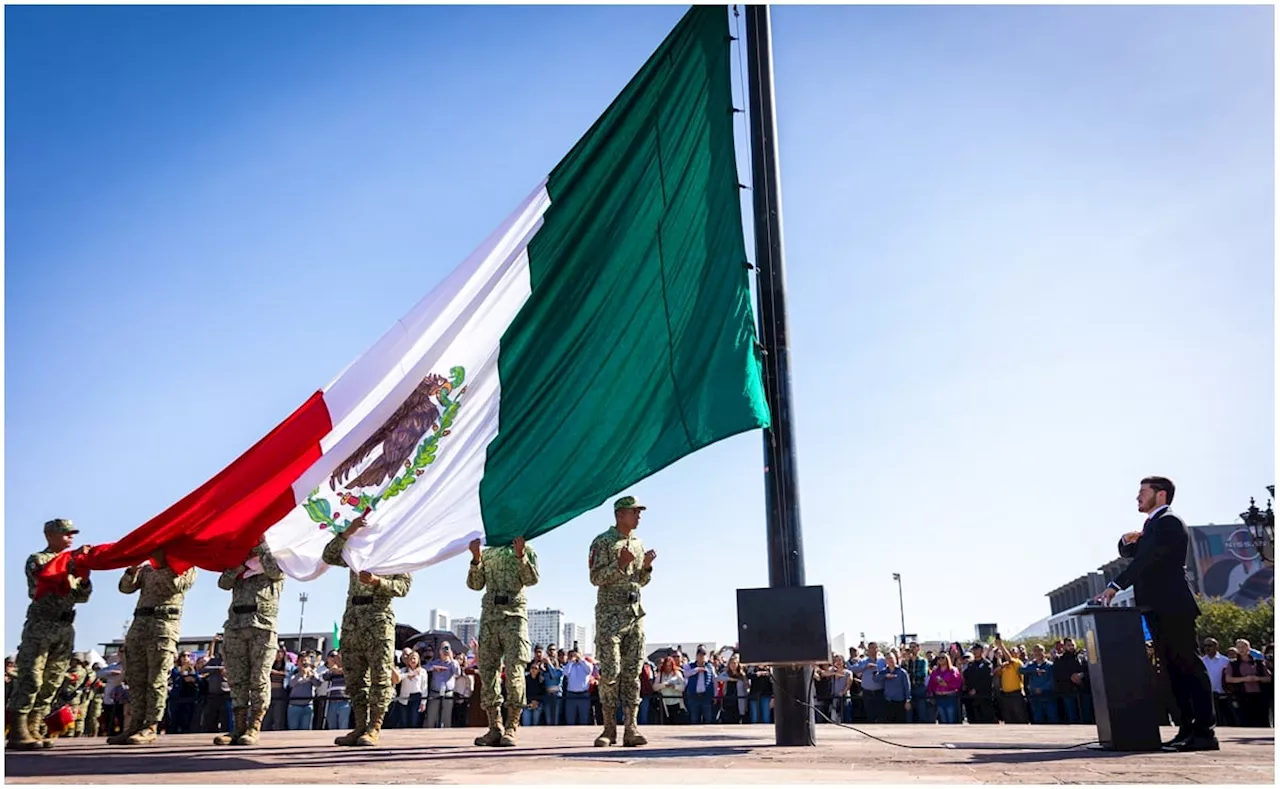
left=5, top=627, right=1275, bottom=736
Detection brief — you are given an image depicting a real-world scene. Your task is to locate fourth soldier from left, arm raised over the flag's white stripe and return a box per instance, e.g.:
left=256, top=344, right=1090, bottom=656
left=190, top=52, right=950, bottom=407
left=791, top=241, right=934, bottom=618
left=321, top=516, right=413, bottom=745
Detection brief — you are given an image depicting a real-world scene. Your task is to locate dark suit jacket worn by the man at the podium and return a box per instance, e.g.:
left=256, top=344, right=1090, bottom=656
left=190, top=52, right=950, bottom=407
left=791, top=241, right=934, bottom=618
left=1115, top=510, right=1199, bottom=616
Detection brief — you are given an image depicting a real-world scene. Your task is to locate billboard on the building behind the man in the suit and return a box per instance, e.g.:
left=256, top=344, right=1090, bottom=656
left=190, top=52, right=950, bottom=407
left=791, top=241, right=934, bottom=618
left=1190, top=524, right=1275, bottom=607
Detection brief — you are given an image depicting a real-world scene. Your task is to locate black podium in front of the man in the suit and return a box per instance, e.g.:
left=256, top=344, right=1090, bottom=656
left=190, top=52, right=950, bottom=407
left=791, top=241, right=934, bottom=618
left=1076, top=606, right=1161, bottom=751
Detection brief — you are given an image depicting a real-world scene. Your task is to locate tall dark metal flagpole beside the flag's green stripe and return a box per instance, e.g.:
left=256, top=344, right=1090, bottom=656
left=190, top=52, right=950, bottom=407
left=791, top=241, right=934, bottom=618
left=746, top=5, right=815, bottom=745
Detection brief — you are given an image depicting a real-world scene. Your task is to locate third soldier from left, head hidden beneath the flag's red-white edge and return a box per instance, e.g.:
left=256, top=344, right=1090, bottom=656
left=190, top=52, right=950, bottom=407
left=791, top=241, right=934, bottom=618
left=210, top=539, right=284, bottom=745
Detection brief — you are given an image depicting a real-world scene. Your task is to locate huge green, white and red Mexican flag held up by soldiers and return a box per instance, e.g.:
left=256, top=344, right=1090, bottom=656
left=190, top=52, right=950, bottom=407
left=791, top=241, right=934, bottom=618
left=72, top=6, right=769, bottom=579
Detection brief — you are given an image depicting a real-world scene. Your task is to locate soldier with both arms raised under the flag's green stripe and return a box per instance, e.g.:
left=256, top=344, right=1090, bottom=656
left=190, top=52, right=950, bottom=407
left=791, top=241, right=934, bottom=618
left=467, top=537, right=538, bottom=748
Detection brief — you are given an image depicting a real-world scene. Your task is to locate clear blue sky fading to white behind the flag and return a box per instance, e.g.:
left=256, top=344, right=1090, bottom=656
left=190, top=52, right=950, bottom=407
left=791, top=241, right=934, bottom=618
left=4, top=6, right=1275, bottom=652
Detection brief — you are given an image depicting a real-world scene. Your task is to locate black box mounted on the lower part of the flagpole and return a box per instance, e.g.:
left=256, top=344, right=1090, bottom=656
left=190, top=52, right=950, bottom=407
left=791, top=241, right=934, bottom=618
left=737, top=587, right=831, bottom=665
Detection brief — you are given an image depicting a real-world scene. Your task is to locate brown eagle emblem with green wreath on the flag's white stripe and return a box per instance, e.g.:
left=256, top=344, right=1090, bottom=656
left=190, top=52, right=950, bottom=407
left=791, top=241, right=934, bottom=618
left=303, top=368, right=467, bottom=533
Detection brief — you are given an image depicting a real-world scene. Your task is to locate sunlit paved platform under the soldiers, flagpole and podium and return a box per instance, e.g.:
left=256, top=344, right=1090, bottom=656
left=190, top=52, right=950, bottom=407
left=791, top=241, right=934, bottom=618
left=5, top=725, right=1275, bottom=786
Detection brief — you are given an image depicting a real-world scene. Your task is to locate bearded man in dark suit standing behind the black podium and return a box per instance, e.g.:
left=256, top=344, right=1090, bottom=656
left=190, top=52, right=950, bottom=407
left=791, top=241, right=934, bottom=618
left=1101, top=476, right=1219, bottom=751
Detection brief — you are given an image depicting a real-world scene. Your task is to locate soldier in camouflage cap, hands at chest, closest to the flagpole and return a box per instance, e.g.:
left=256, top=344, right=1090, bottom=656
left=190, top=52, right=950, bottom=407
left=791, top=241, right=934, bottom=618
left=589, top=496, right=658, bottom=748
